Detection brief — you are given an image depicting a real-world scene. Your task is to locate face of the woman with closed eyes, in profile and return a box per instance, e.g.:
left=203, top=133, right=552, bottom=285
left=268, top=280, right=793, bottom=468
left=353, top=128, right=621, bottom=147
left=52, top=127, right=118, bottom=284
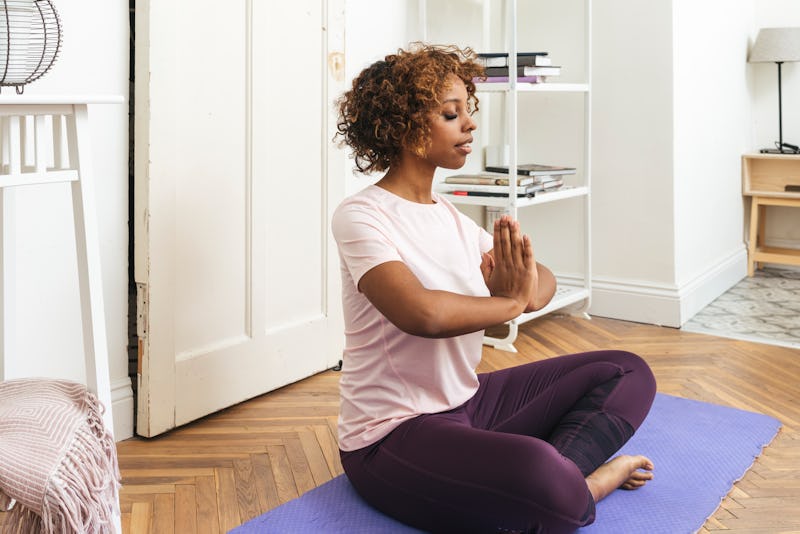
left=425, top=75, right=477, bottom=169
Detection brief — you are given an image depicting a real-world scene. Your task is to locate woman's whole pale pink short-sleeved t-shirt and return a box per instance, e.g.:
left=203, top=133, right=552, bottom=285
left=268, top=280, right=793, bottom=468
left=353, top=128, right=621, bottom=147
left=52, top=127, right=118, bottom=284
left=332, top=185, right=493, bottom=451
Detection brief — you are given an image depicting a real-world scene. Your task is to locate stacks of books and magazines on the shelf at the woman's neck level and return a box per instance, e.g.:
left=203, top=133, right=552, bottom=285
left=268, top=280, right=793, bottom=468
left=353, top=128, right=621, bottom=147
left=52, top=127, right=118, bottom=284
left=436, top=171, right=564, bottom=197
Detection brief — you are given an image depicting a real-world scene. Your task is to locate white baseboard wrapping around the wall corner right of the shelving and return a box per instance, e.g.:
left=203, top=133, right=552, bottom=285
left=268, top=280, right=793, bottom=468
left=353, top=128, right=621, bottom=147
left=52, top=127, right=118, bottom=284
left=589, top=248, right=747, bottom=328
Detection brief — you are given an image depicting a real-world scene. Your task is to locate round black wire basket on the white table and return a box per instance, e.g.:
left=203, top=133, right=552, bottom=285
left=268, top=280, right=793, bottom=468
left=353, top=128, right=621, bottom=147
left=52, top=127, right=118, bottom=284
left=0, top=0, right=61, bottom=94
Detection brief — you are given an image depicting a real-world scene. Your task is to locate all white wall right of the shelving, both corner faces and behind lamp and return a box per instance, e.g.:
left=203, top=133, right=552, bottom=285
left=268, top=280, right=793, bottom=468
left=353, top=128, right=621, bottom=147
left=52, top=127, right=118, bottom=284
left=590, top=0, right=800, bottom=326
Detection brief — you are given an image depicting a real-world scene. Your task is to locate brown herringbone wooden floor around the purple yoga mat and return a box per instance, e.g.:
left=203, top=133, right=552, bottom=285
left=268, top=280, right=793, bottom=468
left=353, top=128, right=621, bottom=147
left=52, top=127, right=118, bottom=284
left=118, top=316, right=800, bottom=534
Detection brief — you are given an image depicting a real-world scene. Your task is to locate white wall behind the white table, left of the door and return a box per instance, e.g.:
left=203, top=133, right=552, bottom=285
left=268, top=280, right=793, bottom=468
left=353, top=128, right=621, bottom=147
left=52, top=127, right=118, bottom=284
left=5, top=0, right=133, bottom=439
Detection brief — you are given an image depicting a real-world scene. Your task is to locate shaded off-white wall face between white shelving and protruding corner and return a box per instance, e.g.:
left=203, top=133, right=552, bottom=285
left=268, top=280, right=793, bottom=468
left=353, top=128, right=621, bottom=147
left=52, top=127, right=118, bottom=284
left=590, top=0, right=676, bottom=324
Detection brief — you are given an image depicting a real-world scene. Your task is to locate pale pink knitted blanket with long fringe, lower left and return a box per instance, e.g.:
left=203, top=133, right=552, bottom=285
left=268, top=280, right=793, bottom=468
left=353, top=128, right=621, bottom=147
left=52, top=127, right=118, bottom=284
left=0, top=379, right=120, bottom=533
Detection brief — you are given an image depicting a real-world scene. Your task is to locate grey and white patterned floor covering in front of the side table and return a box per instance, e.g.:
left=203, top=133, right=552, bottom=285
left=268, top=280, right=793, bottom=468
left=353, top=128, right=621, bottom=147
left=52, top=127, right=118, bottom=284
left=681, top=268, right=800, bottom=348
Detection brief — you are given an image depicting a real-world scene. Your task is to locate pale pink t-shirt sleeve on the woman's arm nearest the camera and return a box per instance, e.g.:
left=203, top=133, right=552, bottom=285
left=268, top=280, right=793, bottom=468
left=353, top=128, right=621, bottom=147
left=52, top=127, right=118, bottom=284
left=331, top=202, right=402, bottom=287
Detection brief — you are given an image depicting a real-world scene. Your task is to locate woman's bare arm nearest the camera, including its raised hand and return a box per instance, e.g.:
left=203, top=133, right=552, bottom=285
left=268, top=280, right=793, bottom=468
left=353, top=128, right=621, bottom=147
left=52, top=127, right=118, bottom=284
left=359, top=219, right=537, bottom=337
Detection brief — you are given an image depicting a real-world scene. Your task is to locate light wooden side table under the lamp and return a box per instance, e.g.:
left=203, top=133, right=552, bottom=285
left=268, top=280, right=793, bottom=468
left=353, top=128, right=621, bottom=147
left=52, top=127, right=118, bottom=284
left=742, top=154, right=800, bottom=276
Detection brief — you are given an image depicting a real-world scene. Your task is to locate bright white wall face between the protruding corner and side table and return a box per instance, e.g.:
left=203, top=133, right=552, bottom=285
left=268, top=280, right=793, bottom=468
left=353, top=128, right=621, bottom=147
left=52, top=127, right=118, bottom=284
left=673, top=0, right=753, bottom=323
